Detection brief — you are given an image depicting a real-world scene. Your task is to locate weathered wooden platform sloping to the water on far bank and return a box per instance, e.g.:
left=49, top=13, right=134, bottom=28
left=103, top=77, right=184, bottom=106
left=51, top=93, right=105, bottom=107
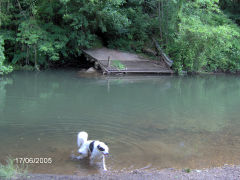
left=83, top=48, right=173, bottom=74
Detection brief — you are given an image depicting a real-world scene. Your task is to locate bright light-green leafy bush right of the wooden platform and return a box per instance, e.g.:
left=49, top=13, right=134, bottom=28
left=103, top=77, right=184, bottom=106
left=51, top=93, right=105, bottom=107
left=168, top=0, right=240, bottom=72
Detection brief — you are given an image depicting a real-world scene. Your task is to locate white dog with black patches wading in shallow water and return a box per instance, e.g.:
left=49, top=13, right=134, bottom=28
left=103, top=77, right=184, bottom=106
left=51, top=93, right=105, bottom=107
left=77, top=131, right=109, bottom=171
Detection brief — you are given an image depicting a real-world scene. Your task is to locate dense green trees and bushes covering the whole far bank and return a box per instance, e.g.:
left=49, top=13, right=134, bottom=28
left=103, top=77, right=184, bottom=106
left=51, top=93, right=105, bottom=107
left=0, top=0, right=240, bottom=72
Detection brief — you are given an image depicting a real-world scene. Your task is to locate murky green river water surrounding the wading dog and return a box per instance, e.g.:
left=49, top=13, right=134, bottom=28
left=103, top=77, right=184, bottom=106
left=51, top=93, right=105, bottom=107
left=0, top=70, right=240, bottom=175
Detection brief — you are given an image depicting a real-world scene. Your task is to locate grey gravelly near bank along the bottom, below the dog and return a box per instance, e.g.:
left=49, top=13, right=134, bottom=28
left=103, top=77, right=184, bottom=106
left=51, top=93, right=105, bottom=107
left=17, top=165, right=240, bottom=180
